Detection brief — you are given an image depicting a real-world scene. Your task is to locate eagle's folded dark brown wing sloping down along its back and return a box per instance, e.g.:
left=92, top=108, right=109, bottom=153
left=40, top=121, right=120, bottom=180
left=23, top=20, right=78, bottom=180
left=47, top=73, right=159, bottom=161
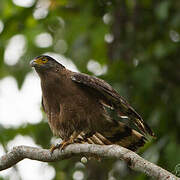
left=71, top=73, right=154, bottom=136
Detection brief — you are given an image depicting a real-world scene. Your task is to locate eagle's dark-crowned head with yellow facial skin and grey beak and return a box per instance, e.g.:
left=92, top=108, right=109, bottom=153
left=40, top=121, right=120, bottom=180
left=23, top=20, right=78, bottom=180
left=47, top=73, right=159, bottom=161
left=30, top=55, right=65, bottom=72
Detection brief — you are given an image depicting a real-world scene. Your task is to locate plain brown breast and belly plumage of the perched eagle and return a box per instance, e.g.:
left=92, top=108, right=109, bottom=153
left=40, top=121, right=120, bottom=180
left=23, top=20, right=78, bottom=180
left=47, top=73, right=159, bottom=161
left=42, top=77, right=107, bottom=139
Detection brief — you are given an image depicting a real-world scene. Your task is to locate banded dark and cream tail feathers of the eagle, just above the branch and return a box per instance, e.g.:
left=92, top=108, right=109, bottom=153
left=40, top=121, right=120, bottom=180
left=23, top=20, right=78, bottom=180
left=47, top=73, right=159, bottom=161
left=79, top=122, right=146, bottom=151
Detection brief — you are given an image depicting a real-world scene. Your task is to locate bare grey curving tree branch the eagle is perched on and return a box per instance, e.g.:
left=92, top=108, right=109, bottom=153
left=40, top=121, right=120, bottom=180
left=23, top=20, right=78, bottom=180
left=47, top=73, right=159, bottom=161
left=0, top=144, right=180, bottom=180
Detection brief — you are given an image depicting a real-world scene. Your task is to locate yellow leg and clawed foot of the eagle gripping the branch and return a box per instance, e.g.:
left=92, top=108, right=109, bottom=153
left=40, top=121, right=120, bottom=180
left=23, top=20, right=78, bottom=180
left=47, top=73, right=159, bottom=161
left=50, top=131, right=79, bottom=154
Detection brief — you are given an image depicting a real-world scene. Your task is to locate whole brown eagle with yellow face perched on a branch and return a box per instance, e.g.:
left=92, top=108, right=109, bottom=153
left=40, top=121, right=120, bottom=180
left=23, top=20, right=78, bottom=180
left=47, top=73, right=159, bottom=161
left=30, top=55, right=154, bottom=152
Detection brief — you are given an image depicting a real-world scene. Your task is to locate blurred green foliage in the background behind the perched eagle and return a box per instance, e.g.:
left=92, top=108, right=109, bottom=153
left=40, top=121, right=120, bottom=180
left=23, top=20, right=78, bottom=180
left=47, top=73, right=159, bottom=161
left=0, top=0, right=180, bottom=180
